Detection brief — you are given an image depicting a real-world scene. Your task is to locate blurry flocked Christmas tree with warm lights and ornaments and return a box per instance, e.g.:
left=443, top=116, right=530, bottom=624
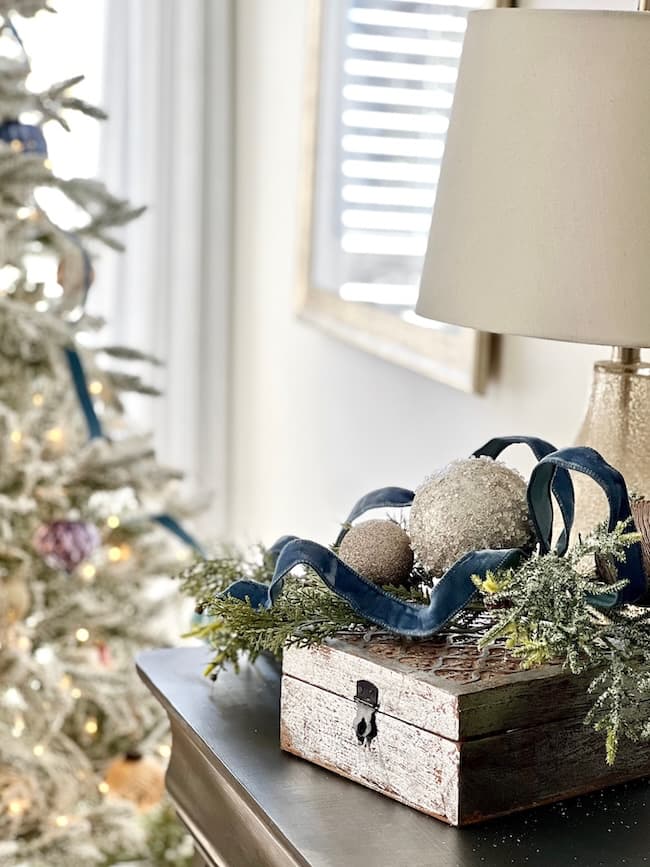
left=0, top=0, right=197, bottom=867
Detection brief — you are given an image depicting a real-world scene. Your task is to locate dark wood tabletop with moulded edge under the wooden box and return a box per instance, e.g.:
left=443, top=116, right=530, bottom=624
left=137, top=648, right=650, bottom=867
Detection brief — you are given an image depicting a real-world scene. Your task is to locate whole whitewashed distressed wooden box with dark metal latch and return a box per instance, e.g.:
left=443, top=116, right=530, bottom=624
left=280, top=639, right=650, bottom=825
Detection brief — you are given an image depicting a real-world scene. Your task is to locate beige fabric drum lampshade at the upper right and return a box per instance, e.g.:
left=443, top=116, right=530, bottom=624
left=417, top=9, right=650, bottom=346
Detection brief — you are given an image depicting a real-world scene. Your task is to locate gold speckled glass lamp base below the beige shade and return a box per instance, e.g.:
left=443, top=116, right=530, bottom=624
left=574, top=347, right=650, bottom=533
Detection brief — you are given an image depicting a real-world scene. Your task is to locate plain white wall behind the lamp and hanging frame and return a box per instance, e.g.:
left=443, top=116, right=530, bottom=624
left=229, top=0, right=606, bottom=542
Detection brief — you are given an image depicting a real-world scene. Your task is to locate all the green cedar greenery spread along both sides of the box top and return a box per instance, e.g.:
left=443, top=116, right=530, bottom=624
left=180, top=523, right=650, bottom=765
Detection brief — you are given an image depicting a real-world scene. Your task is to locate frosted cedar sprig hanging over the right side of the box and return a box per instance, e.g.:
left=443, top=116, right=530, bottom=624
left=474, top=522, right=650, bottom=765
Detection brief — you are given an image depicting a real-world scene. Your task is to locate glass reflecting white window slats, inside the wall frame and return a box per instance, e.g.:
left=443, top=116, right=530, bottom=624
left=312, top=0, right=482, bottom=308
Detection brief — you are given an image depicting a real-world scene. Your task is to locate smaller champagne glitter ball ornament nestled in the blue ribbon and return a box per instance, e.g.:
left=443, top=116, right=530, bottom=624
left=338, top=520, right=413, bottom=585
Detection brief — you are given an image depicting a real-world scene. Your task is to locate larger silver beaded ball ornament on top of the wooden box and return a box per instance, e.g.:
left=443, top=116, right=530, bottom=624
left=409, top=457, right=535, bottom=578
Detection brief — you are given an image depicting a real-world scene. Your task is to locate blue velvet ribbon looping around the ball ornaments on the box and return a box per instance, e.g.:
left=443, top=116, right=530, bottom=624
left=223, top=436, right=646, bottom=638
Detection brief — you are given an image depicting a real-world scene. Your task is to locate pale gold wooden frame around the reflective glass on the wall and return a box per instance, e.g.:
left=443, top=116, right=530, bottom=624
left=296, top=0, right=512, bottom=392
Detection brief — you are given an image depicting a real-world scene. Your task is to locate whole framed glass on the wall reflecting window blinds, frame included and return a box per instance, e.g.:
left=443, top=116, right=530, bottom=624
left=300, top=0, right=498, bottom=390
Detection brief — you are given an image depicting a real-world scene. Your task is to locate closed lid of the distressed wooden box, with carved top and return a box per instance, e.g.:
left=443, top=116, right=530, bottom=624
left=283, top=635, right=593, bottom=741
